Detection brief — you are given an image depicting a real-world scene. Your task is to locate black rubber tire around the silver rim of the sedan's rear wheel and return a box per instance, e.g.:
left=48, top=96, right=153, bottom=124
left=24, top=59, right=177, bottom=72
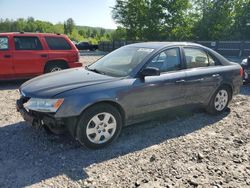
left=206, top=86, right=232, bottom=115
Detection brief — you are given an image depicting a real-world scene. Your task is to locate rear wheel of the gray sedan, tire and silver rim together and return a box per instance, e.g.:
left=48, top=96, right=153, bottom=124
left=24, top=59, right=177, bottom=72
left=206, top=86, right=232, bottom=115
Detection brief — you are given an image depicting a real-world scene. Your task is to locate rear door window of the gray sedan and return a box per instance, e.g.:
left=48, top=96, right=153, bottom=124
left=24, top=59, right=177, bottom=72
left=184, top=48, right=215, bottom=68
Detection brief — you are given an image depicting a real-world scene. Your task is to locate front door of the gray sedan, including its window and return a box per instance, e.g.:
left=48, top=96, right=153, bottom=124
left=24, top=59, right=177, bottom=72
left=126, top=48, right=186, bottom=116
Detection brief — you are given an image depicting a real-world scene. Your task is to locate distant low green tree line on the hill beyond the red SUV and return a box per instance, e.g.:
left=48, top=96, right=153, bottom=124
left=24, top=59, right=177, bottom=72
left=0, top=17, right=113, bottom=44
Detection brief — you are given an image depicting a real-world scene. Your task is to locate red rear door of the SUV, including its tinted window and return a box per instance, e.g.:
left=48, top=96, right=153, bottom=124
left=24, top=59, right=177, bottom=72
left=13, top=36, right=48, bottom=76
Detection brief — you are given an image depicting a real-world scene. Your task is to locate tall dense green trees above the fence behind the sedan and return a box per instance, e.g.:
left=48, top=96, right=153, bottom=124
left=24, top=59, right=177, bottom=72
left=112, top=0, right=250, bottom=41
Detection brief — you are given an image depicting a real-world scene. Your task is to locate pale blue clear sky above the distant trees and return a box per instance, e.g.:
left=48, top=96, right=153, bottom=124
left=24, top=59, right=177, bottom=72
left=0, top=0, right=117, bottom=29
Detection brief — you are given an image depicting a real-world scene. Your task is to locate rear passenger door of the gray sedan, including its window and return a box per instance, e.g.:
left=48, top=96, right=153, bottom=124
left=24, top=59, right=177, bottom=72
left=183, top=47, right=221, bottom=104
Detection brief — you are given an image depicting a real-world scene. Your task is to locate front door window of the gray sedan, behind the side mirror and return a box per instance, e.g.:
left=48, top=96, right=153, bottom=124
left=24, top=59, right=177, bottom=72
left=147, top=48, right=181, bottom=72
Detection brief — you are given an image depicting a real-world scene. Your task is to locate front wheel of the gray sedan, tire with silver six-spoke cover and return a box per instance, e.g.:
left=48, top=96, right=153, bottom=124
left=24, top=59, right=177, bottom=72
left=76, top=104, right=122, bottom=149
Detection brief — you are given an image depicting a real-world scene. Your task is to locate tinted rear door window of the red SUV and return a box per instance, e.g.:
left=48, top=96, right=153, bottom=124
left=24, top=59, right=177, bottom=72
left=14, top=36, right=43, bottom=50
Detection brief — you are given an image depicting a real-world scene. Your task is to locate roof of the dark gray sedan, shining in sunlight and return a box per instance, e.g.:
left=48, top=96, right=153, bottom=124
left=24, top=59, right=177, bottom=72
left=128, top=42, right=201, bottom=49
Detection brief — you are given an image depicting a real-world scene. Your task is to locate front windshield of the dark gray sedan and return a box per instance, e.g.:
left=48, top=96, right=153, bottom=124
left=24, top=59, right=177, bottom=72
left=87, top=46, right=154, bottom=77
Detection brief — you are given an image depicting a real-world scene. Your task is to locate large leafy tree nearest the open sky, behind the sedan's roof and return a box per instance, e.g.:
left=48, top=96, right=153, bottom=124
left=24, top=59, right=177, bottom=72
left=112, top=0, right=190, bottom=40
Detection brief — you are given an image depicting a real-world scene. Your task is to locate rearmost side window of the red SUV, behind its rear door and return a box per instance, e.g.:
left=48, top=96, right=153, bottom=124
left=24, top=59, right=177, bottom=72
left=45, top=37, right=71, bottom=50
